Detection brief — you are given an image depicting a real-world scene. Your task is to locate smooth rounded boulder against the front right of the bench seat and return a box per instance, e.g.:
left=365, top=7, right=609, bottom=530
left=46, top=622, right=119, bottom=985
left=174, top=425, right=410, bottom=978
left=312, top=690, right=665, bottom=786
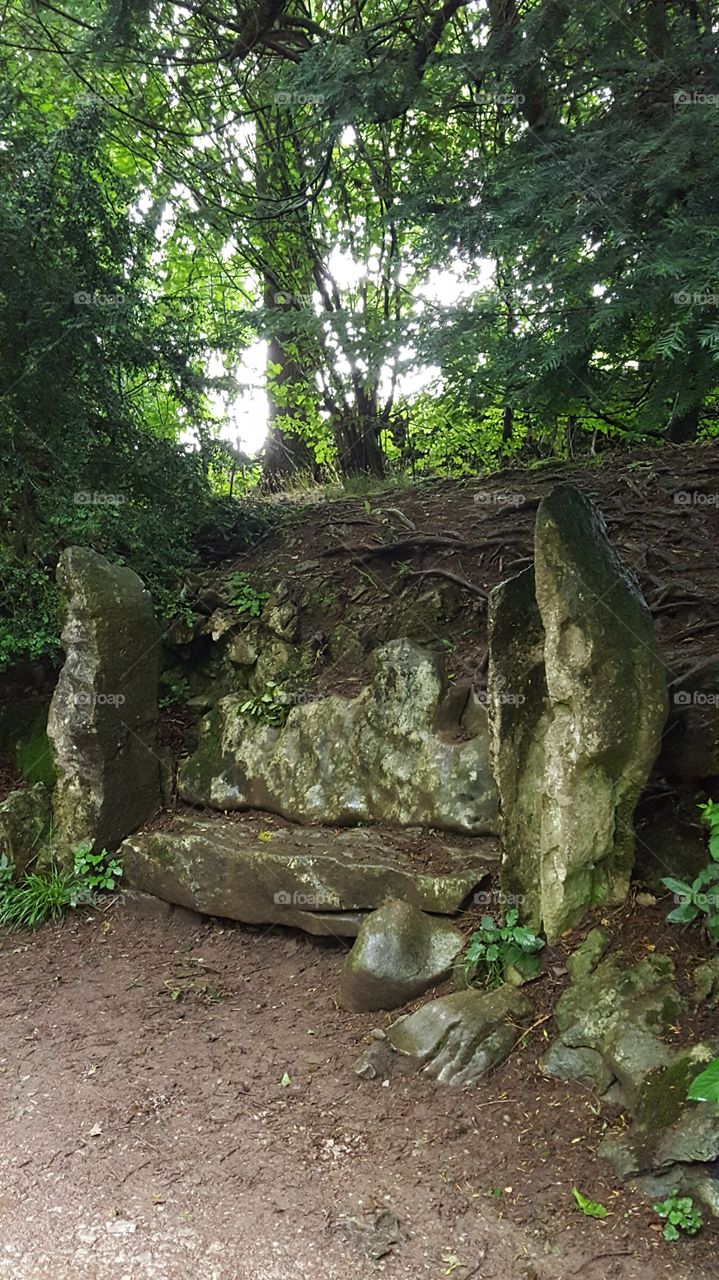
left=339, top=899, right=464, bottom=1012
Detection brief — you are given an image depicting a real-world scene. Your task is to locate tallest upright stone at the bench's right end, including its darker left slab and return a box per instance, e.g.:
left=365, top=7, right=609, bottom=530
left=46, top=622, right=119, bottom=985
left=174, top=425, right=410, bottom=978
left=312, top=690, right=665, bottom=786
left=489, top=485, right=667, bottom=941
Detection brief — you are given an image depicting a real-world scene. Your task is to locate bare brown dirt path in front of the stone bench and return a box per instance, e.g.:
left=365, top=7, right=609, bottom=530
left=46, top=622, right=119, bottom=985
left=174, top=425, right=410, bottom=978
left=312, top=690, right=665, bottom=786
left=0, top=906, right=716, bottom=1280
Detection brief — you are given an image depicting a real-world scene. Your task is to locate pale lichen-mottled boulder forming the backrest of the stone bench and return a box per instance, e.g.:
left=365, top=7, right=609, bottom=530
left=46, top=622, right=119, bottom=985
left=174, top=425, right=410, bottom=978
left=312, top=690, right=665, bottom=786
left=178, top=640, right=498, bottom=835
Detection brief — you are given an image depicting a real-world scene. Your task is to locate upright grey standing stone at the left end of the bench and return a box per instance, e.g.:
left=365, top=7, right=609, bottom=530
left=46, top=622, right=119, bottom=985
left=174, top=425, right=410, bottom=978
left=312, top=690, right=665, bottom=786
left=47, top=547, right=160, bottom=849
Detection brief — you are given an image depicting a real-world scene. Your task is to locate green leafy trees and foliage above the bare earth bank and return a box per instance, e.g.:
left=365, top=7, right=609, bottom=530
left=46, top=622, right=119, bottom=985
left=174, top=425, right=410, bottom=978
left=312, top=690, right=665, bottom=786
left=0, top=0, right=719, bottom=663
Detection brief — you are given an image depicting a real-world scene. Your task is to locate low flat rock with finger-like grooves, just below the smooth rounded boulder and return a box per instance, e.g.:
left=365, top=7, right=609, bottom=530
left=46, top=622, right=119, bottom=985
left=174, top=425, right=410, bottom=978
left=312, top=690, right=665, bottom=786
left=388, top=984, right=532, bottom=1085
